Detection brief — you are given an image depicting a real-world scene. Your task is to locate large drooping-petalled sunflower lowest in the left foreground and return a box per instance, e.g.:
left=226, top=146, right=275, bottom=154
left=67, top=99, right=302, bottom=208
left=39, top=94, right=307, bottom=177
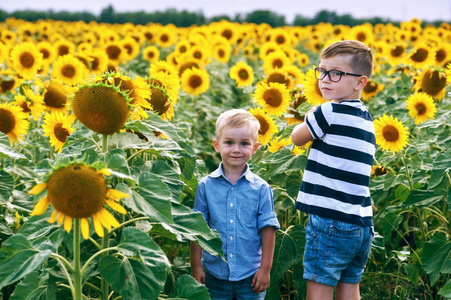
left=28, top=163, right=129, bottom=239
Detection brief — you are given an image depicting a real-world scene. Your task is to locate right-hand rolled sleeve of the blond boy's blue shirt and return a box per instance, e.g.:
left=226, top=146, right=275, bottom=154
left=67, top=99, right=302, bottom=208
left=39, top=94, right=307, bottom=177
left=257, top=184, right=280, bottom=232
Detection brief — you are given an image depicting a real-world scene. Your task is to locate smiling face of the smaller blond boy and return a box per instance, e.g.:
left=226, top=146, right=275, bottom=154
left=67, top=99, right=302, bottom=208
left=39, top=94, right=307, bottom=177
left=213, top=125, right=259, bottom=170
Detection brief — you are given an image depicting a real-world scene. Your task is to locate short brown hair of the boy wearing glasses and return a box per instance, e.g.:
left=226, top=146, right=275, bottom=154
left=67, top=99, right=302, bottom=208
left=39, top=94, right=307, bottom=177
left=320, top=40, right=374, bottom=78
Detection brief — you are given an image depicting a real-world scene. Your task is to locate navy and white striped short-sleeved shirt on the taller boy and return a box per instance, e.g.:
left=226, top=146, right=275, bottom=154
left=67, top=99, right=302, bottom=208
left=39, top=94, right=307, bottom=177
left=295, top=100, right=376, bottom=226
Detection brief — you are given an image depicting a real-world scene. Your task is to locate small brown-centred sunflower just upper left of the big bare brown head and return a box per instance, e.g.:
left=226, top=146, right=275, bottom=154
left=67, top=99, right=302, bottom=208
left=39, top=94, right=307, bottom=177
left=41, top=80, right=69, bottom=112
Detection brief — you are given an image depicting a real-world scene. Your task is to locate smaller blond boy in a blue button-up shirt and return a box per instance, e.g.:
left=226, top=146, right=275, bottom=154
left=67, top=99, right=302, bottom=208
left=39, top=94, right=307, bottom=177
left=191, top=109, right=280, bottom=300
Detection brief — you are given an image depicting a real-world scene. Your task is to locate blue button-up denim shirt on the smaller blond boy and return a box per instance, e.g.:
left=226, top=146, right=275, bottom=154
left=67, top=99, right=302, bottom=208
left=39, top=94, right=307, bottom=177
left=194, top=163, right=280, bottom=281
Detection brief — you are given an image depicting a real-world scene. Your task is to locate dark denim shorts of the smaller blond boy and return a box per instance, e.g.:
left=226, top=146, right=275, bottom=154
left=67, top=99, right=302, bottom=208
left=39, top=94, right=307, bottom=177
left=205, top=272, right=266, bottom=300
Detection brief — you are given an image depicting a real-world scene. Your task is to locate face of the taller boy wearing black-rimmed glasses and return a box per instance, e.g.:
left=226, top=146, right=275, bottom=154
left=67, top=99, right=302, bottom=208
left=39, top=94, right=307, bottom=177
left=318, top=55, right=368, bottom=102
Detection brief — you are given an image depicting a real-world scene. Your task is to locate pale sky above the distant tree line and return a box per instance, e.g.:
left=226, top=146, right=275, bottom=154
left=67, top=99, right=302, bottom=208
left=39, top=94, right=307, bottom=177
left=0, top=0, right=451, bottom=22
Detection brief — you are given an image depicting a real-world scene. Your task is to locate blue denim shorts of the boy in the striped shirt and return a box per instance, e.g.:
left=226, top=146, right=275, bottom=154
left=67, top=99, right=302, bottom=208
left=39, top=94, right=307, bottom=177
left=303, top=214, right=373, bottom=287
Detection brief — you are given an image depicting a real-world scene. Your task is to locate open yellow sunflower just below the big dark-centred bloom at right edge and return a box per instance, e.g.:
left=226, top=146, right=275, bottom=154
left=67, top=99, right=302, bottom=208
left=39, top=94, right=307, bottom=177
left=406, top=92, right=437, bottom=124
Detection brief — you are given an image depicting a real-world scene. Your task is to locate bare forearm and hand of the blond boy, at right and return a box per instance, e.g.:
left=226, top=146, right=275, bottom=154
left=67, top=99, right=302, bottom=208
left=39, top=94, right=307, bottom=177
left=252, top=226, right=276, bottom=293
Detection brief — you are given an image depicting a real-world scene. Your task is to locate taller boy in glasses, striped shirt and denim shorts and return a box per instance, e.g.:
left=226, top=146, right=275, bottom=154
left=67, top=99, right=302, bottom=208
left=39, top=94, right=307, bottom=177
left=292, top=40, right=375, bottom=300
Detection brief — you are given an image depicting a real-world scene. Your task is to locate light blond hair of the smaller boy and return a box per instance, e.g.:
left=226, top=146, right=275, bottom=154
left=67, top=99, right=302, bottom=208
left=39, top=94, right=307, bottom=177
left=215, top=109, right=260, bottom=141
